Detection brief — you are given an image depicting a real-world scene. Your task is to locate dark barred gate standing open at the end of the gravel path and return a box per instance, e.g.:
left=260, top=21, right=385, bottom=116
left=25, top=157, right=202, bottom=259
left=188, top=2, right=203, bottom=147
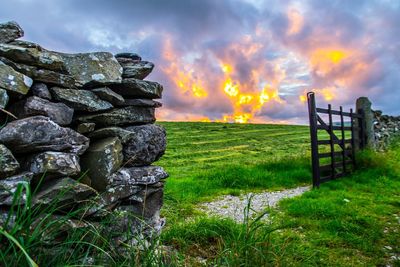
left=307, top=92, right=366, bottom=187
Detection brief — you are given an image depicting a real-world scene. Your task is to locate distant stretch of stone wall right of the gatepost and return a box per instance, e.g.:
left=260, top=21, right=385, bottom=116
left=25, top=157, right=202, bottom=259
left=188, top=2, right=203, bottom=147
left=373, top=110, right=400, bottom=150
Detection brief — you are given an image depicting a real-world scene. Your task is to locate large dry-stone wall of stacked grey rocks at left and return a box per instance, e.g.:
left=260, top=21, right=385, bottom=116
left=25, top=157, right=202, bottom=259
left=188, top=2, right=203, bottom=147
left=0, top=22, right=168, bottom=245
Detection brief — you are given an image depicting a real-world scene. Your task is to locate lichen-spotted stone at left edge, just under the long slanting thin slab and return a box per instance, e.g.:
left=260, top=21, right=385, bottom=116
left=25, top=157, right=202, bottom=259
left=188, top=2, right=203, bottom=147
left=0, top=60, right=33, bottom=95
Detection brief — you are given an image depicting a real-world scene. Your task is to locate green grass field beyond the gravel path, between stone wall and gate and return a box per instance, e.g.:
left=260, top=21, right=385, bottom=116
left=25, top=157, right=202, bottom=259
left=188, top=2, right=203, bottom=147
left=156, top=122, right=311, bottom=210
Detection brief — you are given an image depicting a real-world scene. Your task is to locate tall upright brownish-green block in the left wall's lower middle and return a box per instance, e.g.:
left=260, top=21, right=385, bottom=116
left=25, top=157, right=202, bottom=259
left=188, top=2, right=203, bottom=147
left=81, top=137, right=123, bottom=191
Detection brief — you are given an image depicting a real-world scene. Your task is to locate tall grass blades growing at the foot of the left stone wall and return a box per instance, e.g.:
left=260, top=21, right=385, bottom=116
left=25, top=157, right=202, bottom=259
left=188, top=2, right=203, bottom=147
left=0, top=178, right=170, bottom=267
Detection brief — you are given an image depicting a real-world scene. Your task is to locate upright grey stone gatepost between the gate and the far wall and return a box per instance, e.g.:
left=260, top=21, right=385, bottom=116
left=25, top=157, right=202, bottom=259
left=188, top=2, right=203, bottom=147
left=356, top=97, right=375, bottom=150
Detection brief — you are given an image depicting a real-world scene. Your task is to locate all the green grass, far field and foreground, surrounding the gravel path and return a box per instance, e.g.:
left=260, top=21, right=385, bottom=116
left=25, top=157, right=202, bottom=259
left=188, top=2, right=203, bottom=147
left=0, top=122, right=400, bottom=267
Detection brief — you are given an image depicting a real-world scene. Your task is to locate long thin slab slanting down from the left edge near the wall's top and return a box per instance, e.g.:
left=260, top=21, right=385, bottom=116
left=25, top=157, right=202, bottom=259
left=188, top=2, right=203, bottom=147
left=0, top=57, right=80, bottom=88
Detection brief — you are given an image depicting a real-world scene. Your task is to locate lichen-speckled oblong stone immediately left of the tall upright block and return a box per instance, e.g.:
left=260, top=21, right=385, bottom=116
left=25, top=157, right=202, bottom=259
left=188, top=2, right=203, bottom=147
left=27, top=151, right=81, bottom=176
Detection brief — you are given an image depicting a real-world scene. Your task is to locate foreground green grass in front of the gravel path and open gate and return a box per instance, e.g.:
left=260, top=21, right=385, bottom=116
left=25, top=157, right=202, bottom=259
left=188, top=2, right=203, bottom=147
left=163, top=139, right=400, bottom=266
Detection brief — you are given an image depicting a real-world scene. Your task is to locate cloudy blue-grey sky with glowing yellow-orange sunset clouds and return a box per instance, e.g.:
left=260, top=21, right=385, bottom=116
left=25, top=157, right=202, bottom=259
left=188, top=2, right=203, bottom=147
left=0, top=0, right=400, bottom=124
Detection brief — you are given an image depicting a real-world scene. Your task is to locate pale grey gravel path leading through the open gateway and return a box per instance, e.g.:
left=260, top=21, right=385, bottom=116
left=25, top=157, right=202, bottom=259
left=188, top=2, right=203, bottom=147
left=200, top=186, right=311, bottom=223
